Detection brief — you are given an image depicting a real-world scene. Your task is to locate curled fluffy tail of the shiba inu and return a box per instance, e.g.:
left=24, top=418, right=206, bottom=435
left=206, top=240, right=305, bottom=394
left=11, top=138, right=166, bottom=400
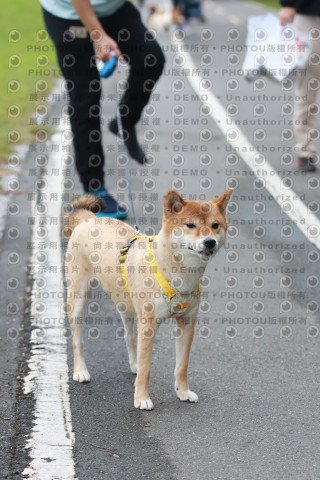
left=61, top=193, right=106, bottom=238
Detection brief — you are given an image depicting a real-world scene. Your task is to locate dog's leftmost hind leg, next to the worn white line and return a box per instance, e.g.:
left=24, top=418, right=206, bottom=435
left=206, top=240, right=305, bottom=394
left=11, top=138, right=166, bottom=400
left=66, top=275, right=90, bottom=383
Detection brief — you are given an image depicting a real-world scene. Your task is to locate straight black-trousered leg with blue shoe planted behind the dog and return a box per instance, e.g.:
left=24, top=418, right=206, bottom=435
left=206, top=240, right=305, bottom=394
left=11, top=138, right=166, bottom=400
left=43, top=10, right=126, bottom=218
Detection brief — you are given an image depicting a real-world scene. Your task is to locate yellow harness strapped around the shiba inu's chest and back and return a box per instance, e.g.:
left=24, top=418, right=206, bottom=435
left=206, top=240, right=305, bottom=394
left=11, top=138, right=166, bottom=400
left=119, top=235, right=202, bottom=316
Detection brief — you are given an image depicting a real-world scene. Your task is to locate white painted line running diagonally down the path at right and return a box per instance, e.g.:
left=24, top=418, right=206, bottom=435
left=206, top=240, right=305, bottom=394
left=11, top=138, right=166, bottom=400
left=175, top=40, right=320, bottom=249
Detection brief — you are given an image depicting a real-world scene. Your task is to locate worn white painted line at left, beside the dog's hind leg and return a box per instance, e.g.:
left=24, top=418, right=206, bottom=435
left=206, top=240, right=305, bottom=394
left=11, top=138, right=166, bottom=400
left=23, top=94, right=75, bottom=480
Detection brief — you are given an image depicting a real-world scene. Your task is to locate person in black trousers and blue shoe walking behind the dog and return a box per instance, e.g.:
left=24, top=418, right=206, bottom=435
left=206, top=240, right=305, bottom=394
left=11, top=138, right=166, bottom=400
left=40, top=0, right=165, bottom=218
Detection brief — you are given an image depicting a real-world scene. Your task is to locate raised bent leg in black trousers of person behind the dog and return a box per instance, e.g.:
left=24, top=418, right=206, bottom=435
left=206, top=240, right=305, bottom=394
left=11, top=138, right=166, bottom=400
left=100, top=2, right=165, bottom=163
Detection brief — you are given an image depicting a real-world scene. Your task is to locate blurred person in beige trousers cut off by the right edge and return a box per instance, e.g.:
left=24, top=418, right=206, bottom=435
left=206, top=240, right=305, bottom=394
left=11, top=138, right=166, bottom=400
left=279, top=0, right=320, bottom=171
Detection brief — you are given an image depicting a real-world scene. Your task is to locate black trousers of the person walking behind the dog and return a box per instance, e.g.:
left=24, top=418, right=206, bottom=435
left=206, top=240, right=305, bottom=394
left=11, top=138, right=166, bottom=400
left=43, top=2, right=165, bottom=191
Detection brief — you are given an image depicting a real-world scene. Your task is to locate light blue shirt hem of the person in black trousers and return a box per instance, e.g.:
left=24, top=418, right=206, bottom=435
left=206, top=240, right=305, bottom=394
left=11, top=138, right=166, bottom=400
left=40, top=0, right=127, bottom=20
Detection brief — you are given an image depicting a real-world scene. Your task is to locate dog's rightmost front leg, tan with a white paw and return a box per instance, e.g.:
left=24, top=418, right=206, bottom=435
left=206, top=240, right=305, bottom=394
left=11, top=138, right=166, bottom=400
left=175, top=317, right=198, bottom=402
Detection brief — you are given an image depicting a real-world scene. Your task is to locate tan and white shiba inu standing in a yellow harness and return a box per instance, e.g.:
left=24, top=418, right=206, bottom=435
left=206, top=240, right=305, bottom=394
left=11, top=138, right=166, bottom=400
left=62, top=189, right=233, bottom=410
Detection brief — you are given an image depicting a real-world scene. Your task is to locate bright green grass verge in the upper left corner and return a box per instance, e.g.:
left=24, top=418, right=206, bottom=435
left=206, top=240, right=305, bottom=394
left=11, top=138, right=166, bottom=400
left=0, top=0, right=60, bottom=164
